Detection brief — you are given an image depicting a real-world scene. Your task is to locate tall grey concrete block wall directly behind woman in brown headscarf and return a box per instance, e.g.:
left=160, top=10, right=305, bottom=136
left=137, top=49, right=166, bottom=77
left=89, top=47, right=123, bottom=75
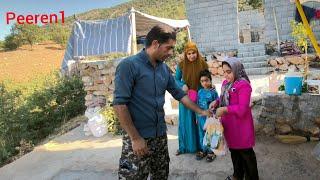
left=185, top=0, right=239, bottom=53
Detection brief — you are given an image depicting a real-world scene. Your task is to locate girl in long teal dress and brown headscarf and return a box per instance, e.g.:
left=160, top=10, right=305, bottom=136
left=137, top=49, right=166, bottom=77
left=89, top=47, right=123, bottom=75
left=175, top=42, right=208, bottom=155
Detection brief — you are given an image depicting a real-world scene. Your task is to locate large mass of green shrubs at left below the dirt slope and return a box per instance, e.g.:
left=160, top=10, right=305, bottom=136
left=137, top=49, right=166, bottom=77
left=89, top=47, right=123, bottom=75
left=0, top=73, right=86, bottom=165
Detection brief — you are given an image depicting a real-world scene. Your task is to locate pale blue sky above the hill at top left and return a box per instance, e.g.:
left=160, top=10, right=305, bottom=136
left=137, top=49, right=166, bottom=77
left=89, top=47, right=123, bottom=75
left=0, top=0, right=130, bottom=40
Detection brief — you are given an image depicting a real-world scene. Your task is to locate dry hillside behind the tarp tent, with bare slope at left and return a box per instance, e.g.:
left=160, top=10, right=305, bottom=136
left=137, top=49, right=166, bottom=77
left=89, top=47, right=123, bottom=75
left=0, top=0, right=186, bottom=82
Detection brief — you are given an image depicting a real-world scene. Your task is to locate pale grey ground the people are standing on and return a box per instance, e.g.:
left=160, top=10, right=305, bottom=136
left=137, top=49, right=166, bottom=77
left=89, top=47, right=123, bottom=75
left=0, top=121, right=320, bottom=180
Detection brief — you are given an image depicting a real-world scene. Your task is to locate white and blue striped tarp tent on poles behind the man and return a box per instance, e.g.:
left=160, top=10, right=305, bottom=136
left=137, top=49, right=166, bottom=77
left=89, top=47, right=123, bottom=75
left=61, top=8, right=190, bottom=72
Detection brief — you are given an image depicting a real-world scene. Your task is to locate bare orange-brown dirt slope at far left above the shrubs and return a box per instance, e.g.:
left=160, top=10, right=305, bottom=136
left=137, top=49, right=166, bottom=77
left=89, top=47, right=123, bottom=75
left=0, top=42, right=64, bottom=82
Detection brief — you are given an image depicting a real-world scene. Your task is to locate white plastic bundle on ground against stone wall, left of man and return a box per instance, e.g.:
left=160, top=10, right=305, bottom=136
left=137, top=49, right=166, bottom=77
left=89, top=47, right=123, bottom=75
left=88, top=113, right=107, bottom=137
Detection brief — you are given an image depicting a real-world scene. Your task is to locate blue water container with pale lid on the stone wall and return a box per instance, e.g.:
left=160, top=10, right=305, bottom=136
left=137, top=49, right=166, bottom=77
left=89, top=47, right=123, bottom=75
left=284, top=73, right=303, bottom=95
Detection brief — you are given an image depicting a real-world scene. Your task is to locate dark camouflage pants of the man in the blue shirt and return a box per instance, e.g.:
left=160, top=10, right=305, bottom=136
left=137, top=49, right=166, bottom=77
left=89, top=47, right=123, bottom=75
left=118, top=134, right=170, bottom=180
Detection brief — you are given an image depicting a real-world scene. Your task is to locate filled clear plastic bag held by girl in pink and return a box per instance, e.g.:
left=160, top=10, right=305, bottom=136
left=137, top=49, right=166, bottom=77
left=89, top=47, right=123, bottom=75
left=203, top=117, right=227, bottom=156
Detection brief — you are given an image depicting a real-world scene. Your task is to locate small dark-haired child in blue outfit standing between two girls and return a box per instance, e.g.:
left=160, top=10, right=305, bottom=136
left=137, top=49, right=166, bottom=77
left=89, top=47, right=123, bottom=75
left=196, top=70, right=218, bottom=162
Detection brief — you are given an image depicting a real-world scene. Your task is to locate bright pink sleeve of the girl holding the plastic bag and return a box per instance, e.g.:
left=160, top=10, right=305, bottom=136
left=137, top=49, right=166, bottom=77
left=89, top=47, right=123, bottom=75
left=227, top=82, right=252, bottom=117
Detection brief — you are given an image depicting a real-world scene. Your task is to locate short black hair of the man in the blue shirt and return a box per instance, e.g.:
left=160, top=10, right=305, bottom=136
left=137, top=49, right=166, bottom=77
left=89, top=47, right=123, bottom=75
left=146, top=25, right=176, bottom=47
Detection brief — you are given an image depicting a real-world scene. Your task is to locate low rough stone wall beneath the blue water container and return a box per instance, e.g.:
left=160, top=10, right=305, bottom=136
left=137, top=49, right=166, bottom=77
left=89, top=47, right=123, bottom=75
left=257, top=93, right=320, bottom=136
